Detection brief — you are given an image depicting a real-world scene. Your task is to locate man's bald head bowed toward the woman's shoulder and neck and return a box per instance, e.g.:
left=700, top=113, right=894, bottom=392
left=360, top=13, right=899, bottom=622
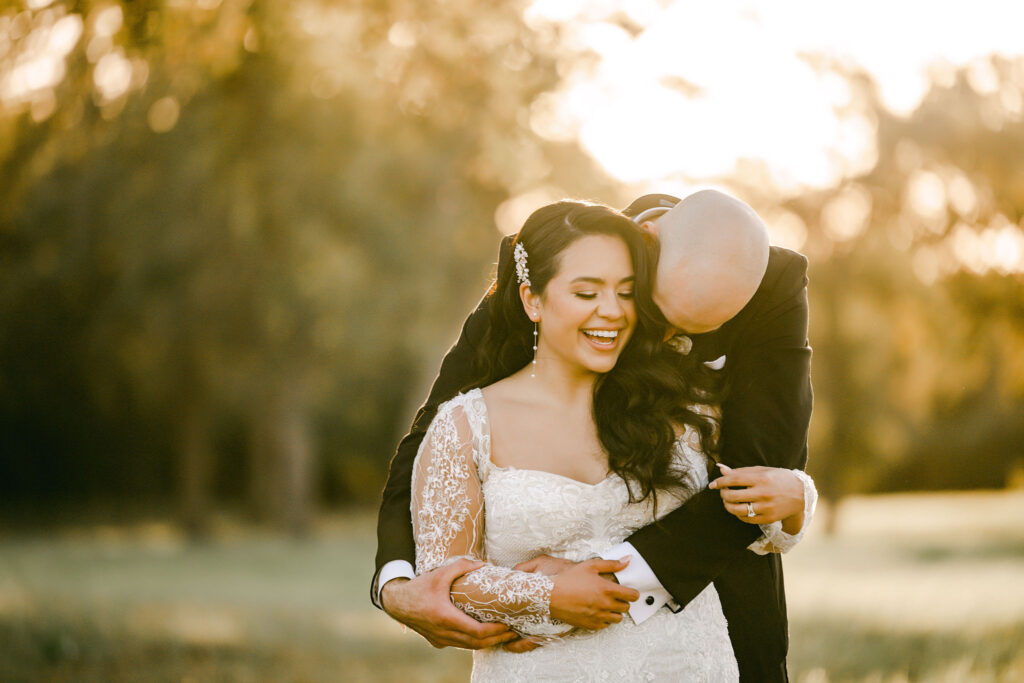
left=641, top=189, right=768, bottom=334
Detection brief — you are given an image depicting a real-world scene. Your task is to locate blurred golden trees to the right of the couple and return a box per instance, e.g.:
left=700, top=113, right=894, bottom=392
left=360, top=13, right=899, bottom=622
left=742, top=58, right=1024, bottom=520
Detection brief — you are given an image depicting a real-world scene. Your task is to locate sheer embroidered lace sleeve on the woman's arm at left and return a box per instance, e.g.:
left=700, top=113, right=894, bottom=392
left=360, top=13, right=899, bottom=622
left=412, top=403, right=571, bottom=636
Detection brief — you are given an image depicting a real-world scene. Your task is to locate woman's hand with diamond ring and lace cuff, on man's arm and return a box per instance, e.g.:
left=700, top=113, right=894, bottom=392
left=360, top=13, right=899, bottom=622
left=710, top=465, right=818, bottom=555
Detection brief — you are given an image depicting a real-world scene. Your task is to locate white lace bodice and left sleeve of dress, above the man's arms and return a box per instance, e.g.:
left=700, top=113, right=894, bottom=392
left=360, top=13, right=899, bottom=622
left=412, top=390, right=708, bottom=636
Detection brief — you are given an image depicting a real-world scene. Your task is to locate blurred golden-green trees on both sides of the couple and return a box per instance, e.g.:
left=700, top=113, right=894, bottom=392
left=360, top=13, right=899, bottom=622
left=0, top=0, right=1024, bottom=520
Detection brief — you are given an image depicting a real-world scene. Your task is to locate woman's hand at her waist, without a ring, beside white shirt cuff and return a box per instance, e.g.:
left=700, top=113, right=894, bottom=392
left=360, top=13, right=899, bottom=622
left=551, top=559, right=640, bottom=631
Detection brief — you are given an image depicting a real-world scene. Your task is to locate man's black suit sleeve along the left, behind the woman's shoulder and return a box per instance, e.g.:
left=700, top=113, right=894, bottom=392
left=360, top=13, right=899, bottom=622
left=371, top=238, right=511, bottom=595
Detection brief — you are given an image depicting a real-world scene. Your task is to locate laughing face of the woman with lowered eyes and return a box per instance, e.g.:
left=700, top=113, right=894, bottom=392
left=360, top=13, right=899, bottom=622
left=526, top=234, right=637, bottom=373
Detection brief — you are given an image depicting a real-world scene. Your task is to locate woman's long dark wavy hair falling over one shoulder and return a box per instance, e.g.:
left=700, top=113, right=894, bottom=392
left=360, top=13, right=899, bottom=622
left=465, top=200, right=720, bottom=502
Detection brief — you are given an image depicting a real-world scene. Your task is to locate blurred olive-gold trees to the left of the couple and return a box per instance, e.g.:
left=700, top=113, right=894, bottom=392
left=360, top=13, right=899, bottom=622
left=0, top=0, right=614, bottom=532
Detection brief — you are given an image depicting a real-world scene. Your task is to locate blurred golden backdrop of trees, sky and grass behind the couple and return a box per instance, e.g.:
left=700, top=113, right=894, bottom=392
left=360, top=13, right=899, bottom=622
left=0, top=0, right=1024, bottom=682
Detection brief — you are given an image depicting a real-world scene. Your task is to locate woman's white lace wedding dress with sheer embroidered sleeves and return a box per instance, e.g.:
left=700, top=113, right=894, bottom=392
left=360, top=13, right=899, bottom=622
left=412, top=389, right=813, bottom=681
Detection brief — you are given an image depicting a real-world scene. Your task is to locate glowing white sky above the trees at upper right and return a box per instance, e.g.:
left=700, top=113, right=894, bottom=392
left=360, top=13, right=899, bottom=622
left=526, top=0, right=1024, bottom=193
